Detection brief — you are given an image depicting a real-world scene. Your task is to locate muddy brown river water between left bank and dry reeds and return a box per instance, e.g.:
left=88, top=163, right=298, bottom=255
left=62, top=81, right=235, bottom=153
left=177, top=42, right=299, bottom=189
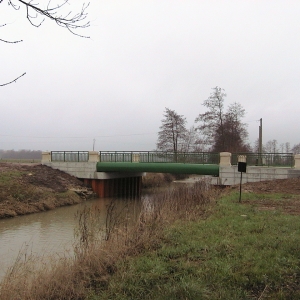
left=0, top=198, right=141, bottom=279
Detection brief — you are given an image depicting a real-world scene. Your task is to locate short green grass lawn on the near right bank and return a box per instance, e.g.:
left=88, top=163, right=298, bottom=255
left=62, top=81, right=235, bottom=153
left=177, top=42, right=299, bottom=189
left=90, top=194, right=300, bottom=300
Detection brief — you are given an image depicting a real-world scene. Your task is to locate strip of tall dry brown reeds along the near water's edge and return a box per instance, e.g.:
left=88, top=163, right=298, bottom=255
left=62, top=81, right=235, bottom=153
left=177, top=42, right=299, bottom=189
left=0, top=181, right=218, bottom=300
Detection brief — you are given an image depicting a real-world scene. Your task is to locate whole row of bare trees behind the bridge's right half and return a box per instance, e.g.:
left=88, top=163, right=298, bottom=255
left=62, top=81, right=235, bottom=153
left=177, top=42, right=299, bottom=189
left=156, top=86, right=300, bottom=154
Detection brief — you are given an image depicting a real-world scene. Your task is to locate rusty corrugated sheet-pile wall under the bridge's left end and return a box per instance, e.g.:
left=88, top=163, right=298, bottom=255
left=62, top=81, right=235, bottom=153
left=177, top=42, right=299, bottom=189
left=84, top=176, right=142, bottom=198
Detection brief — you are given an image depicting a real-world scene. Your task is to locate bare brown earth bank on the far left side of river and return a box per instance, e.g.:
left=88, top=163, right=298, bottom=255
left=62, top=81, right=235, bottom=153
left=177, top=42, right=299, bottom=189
left=0, top=163, right=94, bottom=219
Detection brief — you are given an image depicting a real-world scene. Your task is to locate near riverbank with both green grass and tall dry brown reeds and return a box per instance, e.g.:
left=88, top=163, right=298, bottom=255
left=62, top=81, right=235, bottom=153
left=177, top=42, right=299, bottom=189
left=0, top=179, right=300, bottom=300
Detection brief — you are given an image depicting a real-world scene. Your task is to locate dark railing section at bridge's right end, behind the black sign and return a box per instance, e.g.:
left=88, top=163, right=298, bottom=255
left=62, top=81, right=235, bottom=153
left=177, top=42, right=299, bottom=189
left=231, top=153, right=295, bottom=167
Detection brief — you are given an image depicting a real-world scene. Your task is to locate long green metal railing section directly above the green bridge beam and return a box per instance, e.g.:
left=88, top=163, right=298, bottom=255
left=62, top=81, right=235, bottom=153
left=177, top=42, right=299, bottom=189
left=99, top=151, right=220, bottom=164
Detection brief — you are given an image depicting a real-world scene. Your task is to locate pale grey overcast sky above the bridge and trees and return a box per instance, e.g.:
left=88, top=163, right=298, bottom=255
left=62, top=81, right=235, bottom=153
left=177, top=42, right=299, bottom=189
left=0, top=0, right=300, bottom=151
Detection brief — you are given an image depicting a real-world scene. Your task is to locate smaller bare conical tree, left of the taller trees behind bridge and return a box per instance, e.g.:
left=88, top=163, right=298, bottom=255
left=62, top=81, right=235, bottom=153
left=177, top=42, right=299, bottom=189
left=157, top=108, right=187, bottom=153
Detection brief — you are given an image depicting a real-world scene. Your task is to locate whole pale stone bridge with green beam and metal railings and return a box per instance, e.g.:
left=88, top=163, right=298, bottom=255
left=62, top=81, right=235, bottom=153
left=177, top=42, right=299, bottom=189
left=42, top=151, right=300, bottom=197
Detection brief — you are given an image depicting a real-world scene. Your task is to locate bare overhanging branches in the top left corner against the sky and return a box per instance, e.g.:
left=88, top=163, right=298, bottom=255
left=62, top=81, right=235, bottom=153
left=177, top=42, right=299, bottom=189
left=0, top=0, right=90, bottom=86
